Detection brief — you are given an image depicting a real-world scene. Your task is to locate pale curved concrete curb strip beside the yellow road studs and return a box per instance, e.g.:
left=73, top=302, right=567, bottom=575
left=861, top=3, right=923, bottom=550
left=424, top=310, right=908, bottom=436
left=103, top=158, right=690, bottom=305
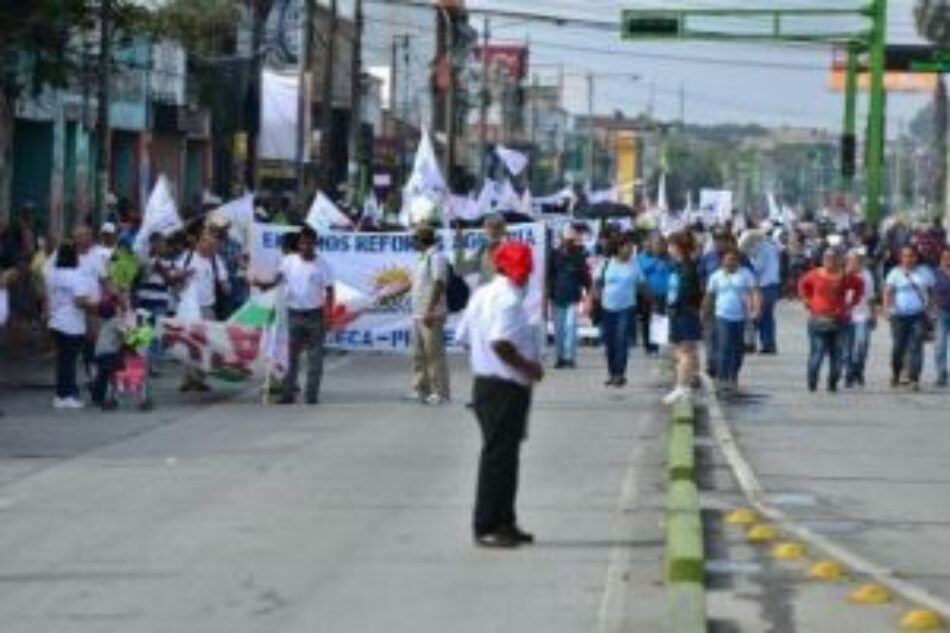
left=703, top=376, right=950, bottom=620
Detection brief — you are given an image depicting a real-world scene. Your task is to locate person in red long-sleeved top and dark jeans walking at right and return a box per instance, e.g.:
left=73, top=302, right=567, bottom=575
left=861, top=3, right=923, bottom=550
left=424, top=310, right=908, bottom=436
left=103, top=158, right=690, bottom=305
left=798, top=248, right=864, bottom=392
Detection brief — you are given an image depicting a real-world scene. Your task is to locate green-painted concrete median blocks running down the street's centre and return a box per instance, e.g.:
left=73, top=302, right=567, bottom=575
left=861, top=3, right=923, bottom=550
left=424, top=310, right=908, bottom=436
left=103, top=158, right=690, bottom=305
left=666, top=403, right=707, bottom=633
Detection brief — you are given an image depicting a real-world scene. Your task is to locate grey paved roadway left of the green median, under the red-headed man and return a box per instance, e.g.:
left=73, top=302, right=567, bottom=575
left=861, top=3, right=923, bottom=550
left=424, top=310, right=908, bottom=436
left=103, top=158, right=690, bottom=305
left=0, top=348, right=664, bottom=633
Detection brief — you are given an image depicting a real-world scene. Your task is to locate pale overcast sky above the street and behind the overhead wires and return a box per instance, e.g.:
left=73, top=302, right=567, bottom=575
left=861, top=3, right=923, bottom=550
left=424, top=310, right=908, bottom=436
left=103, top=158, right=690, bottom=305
left=360, top=0, right=928, bottom=133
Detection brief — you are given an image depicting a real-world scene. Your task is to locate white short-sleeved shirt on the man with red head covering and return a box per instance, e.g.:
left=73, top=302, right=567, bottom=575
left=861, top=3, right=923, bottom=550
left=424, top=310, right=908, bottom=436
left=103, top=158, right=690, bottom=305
left=456, top=275, right=541, bottom=386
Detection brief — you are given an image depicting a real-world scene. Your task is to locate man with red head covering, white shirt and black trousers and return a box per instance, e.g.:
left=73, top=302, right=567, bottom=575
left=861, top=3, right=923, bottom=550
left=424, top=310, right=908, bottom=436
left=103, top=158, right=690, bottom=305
left=458, top=242, right=544, bottom=548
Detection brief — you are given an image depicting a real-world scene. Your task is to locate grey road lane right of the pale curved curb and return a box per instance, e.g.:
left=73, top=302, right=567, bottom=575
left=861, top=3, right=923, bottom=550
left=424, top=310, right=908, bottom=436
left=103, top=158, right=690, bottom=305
left=723, top=304, right=950, bottom=599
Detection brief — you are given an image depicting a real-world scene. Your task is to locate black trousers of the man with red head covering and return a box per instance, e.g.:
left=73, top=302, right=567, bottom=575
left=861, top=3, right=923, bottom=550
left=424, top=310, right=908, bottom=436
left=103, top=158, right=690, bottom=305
left=473, top=377, right=531, bottom=536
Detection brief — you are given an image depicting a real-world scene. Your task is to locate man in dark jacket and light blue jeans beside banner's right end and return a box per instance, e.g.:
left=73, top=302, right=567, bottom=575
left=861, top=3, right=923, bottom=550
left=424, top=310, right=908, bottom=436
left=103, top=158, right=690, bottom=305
left=548, top=224, right=591, bottom=369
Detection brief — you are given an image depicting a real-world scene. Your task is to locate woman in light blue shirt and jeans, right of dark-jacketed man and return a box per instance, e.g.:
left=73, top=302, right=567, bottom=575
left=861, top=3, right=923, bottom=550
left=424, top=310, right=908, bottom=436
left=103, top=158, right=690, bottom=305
left=596, top=233, right=643, bottom=387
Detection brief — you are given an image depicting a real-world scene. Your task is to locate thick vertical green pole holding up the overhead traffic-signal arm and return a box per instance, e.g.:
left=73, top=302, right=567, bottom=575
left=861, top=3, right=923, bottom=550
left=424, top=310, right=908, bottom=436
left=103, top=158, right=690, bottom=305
left=866, top=0, right=887, bottom=225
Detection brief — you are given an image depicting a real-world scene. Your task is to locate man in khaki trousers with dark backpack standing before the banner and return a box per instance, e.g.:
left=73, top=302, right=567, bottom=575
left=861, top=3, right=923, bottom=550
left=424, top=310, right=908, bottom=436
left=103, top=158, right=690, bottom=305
left=412, top=225, right=451, bottom=405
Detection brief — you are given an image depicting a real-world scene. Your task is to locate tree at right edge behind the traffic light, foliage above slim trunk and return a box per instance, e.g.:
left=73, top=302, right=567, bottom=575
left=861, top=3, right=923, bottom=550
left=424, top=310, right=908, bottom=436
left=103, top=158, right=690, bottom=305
left=914, top=0, right=950, bottom=213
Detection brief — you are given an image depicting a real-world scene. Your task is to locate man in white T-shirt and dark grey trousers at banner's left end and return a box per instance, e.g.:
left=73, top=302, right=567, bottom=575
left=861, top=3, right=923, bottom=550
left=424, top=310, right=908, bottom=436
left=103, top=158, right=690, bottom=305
left=255, top=226, right=334, bottom=404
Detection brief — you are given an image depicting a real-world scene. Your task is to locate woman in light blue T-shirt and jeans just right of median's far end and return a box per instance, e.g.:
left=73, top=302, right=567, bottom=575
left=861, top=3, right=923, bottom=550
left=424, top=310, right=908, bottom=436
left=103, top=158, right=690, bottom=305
left=703, top=247, right=761, bottom=393
